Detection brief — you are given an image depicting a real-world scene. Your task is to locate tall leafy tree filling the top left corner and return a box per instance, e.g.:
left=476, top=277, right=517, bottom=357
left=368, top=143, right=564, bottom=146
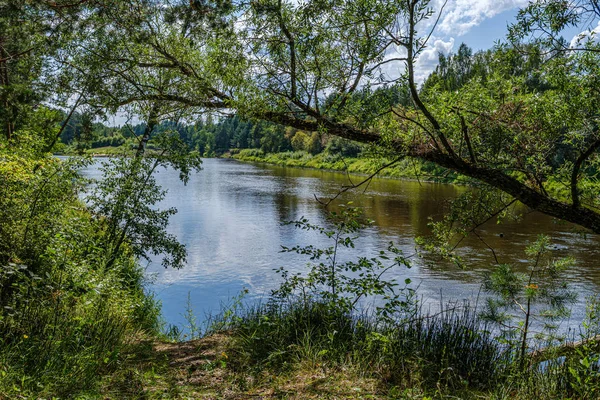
left=0, top=0, right=99, bottom=152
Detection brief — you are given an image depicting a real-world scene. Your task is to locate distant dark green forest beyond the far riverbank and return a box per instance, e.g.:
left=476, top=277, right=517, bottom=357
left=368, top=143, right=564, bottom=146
left=61, top=43, right=571, bottom=165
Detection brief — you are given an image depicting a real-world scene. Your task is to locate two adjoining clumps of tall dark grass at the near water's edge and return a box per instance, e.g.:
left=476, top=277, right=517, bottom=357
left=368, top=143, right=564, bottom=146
left=220, top=298, right=507, bottom=389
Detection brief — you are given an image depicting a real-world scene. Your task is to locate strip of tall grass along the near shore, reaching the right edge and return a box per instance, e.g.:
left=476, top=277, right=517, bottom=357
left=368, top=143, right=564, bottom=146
left=215, top=297, right=600, bottom=399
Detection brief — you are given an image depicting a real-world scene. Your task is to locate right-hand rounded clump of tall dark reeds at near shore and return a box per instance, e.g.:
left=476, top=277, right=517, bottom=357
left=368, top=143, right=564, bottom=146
left=385, top=304, right=507, bottom=389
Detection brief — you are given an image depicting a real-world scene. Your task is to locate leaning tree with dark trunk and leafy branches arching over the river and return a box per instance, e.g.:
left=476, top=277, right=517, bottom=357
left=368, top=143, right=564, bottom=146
left=69, top=0, right=600, bottom=233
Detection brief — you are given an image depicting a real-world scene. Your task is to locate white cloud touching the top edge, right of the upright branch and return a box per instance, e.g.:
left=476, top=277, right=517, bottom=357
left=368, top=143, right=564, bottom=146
left=430, top=0, right=529, bottom=36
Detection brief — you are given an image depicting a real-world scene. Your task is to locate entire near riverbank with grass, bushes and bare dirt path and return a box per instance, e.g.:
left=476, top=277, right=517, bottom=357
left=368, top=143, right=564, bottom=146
left=5, top=148, right=600, bottom=400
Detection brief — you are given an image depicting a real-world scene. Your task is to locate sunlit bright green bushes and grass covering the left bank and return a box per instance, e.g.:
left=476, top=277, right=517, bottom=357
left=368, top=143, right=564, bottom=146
left=0, top=147, right=160, bottom=399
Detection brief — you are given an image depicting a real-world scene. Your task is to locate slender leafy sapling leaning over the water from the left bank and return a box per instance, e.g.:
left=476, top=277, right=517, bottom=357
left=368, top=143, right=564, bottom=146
left=86, top=131, right=201, bottom=268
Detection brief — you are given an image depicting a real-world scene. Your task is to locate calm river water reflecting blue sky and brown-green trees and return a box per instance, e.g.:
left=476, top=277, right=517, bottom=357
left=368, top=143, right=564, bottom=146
left=86, top=159, right=600, bottom=329
